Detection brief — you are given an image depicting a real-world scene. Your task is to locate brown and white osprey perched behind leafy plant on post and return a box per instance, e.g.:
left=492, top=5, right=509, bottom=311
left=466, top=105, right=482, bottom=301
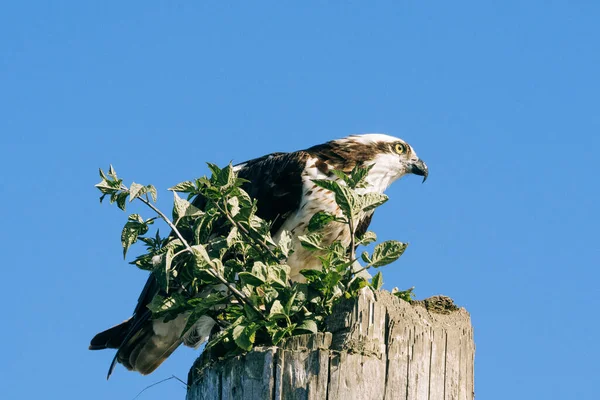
left=90, top=134, right=428, bottom=378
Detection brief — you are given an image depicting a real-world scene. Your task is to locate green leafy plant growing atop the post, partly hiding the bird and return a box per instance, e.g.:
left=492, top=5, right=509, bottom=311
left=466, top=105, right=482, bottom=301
left=96, top=164, right=412, bottom=355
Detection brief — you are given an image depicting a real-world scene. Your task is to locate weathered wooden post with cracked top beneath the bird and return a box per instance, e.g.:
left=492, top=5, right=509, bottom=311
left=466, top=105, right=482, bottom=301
left=187, top=289, right=475, bottom=400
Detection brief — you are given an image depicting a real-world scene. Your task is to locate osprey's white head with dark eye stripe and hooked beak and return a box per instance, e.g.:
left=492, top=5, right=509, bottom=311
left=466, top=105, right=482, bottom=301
left=327, top=133, right=429, bottom=192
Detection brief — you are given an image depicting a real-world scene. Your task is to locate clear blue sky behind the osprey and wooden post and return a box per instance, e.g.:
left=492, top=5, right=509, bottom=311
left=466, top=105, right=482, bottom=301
left=0, top=0, right=600, bottom=400
